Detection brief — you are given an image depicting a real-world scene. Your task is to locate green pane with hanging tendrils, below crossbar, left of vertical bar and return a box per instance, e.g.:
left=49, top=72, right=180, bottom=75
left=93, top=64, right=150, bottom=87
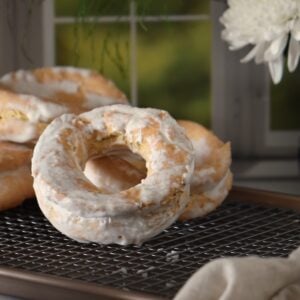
left=56, top=23, right=129, bottom=95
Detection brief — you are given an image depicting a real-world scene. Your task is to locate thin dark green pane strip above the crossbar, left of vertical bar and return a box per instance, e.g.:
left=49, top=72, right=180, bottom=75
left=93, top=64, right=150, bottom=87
left=55, top=0, right=129, bottom=17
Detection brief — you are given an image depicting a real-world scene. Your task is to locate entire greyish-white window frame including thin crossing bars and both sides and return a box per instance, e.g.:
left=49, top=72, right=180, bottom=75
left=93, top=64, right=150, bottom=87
left=0, top=0, right=300, bottom=164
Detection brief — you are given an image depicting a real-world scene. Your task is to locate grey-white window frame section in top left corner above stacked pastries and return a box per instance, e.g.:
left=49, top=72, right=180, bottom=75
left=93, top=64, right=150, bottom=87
left=0, top=0, right=54, bottom=75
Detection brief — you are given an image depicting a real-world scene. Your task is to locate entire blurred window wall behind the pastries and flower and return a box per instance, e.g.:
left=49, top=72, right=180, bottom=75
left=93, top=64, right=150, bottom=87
left=0, top=0, right=300, bottom=195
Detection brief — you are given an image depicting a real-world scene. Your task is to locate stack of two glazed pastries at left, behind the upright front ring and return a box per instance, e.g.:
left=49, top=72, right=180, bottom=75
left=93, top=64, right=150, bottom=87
left=0, top=67, right=128, bottom=210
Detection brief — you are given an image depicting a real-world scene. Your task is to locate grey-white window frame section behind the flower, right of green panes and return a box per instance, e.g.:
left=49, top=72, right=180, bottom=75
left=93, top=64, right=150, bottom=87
left=211, top=0, right=300, bottom=159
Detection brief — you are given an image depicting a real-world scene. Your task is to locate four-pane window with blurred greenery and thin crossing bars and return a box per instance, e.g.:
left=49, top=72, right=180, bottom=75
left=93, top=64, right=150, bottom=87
left=54, top=0, right=211, bottom=126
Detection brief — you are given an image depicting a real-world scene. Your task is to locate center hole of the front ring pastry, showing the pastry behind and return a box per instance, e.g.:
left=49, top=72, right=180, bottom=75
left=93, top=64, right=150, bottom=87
left=84, top=148, right=147, bottom=194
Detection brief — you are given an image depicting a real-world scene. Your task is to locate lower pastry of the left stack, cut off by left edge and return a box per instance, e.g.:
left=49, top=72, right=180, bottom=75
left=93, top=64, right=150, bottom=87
left=0, top=142, right=34, bottom=211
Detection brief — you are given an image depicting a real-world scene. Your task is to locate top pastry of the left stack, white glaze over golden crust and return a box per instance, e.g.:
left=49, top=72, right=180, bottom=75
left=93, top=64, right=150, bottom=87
left=0, top=67, right=128, bottom=143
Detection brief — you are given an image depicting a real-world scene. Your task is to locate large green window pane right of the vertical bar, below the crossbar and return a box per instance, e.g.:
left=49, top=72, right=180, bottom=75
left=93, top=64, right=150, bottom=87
left=138, top=21, right=211, bottom=126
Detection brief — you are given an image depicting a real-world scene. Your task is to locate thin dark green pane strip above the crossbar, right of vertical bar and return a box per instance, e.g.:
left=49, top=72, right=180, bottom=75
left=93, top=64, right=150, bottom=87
left=136, top=0, right=209, bottom=15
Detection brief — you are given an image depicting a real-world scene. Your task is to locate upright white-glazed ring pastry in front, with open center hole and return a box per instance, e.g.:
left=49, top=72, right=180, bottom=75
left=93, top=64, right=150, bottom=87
left=32, top=105, right=194, bottom=245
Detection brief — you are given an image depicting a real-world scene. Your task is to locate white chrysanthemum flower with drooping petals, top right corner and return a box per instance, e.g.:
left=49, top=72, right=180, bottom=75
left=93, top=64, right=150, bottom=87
left=220, top=0, right=300, bottom=83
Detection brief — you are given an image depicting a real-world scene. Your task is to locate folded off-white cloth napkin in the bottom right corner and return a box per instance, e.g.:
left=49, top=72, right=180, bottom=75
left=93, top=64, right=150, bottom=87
left=174, top=248, right=300, bottom=300
